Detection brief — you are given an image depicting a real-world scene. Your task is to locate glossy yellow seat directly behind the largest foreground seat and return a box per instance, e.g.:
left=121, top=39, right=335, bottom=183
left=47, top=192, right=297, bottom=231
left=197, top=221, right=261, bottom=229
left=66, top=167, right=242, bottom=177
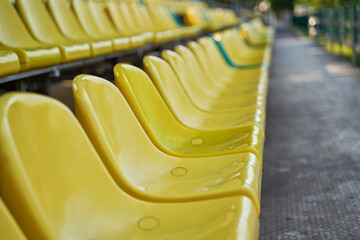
left=73, top=75, right=261, bottom=211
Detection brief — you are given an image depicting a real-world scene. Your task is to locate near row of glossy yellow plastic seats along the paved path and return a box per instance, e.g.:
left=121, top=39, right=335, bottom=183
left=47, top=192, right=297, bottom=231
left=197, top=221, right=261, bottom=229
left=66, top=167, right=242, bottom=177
left=0, top=12, right=272, bottom=239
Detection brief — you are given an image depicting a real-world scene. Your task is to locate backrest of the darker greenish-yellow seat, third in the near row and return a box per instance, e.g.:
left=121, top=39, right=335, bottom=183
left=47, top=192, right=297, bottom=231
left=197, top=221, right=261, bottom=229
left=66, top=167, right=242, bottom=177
left=114, top=64, right=182, bottom=152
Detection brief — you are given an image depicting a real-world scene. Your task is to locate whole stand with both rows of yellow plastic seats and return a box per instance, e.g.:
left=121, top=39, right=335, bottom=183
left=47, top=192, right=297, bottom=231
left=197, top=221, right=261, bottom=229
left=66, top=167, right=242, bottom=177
left=0, top=0, right=274, bottom=240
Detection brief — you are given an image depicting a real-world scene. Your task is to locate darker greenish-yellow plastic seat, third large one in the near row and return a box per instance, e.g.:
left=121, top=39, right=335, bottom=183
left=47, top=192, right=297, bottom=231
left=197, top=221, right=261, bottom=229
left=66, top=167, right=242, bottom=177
left=114, top=64, right=264, bottom=161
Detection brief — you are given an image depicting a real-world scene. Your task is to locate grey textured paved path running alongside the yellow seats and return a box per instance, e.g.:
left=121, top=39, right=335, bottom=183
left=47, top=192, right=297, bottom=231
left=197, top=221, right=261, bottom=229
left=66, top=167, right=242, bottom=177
left=260, top=25, right=360, bottom=240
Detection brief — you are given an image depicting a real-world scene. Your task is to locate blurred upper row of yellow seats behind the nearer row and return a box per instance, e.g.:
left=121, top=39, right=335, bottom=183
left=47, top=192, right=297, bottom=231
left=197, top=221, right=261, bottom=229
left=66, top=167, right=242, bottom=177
left=0, top=0, right=242, bottom=76
